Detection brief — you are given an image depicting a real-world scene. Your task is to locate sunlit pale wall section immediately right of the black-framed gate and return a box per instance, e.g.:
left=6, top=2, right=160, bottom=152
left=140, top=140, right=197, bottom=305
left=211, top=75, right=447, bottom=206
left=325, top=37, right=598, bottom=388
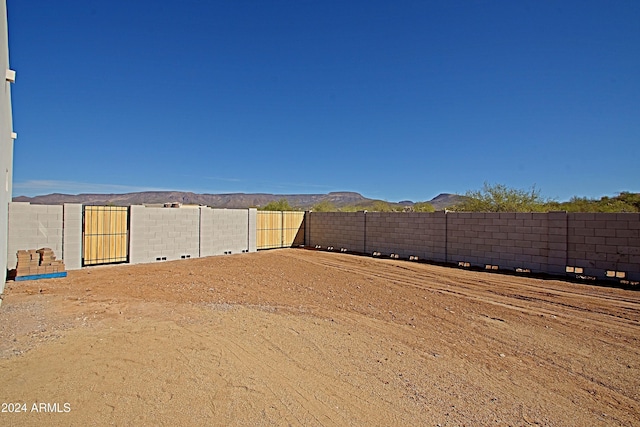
left=129, top=206, right=200, bottom=264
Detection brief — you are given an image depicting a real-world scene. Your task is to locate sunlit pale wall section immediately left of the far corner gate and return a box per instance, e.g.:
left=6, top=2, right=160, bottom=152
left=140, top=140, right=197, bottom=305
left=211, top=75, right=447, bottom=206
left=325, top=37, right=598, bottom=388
left=200, top=207, right=256, bottom=256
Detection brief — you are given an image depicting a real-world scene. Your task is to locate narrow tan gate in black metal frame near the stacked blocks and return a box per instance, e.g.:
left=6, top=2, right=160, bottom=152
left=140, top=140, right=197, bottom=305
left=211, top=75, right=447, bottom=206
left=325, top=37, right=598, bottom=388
left=82, top=206, right=129, bottom=266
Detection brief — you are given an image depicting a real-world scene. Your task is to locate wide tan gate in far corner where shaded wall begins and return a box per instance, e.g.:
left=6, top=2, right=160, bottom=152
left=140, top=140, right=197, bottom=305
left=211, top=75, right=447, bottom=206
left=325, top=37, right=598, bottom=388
left=256, top=211, right=304, bottom=249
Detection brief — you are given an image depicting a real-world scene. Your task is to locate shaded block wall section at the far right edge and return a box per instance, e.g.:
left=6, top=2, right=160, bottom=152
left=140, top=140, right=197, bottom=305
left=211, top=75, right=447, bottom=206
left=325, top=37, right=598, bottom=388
left=567, top=213, right=640, bottom=281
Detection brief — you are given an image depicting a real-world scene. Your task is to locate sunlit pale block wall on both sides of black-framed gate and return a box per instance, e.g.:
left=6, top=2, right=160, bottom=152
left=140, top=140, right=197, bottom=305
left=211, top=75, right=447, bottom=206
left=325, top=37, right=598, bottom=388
left=3, top=202, right=257, bottom=272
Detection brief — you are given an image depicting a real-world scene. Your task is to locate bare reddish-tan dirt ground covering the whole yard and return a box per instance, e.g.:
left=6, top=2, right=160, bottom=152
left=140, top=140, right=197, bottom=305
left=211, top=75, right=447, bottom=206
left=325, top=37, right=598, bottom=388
left=0, top=249, right=640, bottom=426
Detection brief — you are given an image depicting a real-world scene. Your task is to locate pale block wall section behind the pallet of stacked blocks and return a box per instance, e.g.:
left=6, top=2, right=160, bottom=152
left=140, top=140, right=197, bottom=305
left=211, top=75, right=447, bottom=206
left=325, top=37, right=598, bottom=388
left=7, top=202, right=64, bottom=270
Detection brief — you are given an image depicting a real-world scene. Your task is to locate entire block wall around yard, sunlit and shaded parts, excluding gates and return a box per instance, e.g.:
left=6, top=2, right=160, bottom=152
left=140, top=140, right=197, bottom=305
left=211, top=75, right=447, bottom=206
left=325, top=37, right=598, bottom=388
left=7, top=202, right=640, bottom=281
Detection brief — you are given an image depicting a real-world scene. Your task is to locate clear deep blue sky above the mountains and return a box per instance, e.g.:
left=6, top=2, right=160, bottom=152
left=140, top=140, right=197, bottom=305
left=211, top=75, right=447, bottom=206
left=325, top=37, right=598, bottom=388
left=8, top=0, right=640, bottom=201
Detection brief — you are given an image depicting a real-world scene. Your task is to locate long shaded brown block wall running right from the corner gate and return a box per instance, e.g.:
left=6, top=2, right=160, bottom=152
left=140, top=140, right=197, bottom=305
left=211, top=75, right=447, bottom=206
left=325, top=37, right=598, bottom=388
left=305, top=212, right=640, bottom=281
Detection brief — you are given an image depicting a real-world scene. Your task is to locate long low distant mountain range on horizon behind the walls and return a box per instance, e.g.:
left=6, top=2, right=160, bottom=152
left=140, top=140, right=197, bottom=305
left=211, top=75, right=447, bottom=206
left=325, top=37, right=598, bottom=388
left=13, top=191, right=460, bottom=210
